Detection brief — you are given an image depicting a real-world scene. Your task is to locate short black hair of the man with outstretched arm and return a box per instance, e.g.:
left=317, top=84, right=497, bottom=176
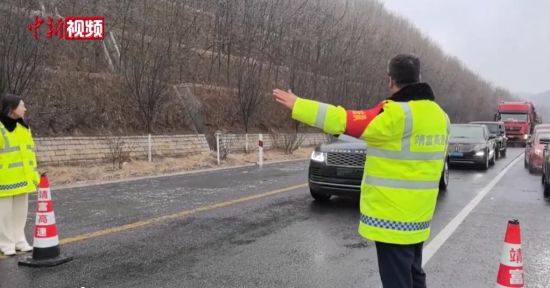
left=388, top=54, right=420, bottom=87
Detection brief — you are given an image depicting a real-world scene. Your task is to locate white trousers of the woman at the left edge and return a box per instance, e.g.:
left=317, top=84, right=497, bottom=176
left=0, top=193, right=29, bottom=249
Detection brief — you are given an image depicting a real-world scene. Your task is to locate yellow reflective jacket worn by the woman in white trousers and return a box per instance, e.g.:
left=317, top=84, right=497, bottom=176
left=0, top=122, right=40, bottom=197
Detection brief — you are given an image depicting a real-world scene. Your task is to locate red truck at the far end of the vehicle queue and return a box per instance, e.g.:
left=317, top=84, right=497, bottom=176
left=495, top=102, right=541, bottom=146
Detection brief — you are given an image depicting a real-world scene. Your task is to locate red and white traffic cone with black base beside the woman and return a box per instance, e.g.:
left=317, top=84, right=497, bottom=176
left=19, top=175, right=73, bottom=267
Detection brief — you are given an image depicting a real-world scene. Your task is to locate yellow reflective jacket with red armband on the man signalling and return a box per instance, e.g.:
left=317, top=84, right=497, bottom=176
left=292, top=94, right=450, bottom=244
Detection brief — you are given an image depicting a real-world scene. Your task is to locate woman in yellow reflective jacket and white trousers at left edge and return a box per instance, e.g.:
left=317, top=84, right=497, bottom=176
left=0, top=94, right=40, bottom=256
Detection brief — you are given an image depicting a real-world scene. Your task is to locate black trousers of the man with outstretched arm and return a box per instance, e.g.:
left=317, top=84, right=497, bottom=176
left=376, top=242, right=426, bottom=288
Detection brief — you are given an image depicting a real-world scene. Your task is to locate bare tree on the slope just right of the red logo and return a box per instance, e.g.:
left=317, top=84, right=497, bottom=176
left=120, top=0, right=178, bottom=133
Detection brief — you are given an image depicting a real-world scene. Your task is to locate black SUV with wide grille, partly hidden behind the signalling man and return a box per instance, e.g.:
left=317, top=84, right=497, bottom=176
left=308, top=135, right=449, bottom=201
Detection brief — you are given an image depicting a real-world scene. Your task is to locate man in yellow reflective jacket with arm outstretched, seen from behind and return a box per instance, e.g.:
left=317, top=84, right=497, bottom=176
left=273, top=54, right=450, bottom=288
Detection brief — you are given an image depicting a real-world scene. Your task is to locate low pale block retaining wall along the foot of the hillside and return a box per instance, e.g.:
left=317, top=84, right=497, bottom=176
left=34, top=133, right=328, bottom=165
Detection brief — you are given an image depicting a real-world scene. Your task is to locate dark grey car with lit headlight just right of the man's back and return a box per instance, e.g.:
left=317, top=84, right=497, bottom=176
left=448, top=124, right=495, bottom=170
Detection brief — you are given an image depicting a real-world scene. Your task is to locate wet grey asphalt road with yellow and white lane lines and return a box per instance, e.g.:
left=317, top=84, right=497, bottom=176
left=0, top=149, right=550, bottom=288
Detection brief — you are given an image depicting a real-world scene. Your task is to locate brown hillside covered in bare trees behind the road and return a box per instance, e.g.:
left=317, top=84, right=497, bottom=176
left=0, top=0, right=511, bottom=136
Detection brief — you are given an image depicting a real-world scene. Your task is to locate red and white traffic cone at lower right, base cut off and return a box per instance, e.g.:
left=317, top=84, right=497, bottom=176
left=497, top=220, right=524, bottom=287
